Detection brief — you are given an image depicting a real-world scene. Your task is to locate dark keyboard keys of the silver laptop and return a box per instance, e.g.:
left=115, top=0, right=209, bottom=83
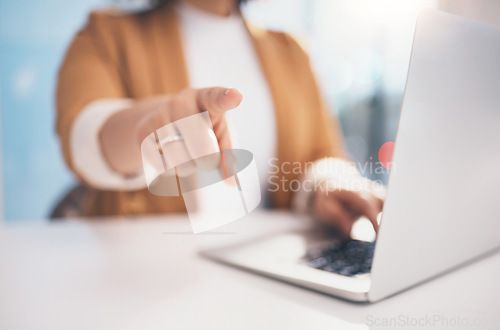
left=305, top=240, right=375, bottom=276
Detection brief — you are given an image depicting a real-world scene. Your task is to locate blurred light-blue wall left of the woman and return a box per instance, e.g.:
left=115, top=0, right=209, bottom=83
left=0, top=0, right=108, bottom=221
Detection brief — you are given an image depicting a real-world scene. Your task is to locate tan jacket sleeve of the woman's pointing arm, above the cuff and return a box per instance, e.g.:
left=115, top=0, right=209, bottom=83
left=56, top=12, right=127, bottom=183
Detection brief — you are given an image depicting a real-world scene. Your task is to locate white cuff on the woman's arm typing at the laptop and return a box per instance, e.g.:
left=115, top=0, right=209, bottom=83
left=292, top=158, right=386, bottom=213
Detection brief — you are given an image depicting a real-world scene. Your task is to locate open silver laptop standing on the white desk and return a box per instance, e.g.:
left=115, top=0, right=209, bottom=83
left=202, top=10, right=500, bottom=302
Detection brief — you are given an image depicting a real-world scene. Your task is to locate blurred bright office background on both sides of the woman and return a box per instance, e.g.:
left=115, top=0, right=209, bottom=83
left=0, top=0, right=500, bottom=221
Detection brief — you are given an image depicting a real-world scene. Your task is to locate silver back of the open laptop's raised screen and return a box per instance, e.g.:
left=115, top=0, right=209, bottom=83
left=369, top=10, right=500, bottom=301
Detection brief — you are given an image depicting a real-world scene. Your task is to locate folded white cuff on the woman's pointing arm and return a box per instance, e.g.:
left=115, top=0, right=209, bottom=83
left=70, top=99, right=146, bottom=191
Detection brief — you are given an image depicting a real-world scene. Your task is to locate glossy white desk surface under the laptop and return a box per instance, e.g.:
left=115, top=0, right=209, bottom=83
left=0, top=212, right=500, bottom=330
